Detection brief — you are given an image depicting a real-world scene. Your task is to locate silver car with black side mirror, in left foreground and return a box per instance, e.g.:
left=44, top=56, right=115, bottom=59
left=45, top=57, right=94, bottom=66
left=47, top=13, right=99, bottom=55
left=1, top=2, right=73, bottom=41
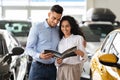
left=0, top=29, right=28, bottom=80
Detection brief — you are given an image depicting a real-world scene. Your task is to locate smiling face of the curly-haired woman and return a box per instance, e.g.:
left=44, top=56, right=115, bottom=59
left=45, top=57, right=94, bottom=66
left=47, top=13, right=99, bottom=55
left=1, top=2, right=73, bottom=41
left=61, top=20, right=71, bottom=37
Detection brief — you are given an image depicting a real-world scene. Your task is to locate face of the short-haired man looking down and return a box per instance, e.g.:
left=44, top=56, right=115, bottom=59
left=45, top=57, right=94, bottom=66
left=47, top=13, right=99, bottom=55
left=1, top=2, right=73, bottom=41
left=48, top=12, right=62, bottom=27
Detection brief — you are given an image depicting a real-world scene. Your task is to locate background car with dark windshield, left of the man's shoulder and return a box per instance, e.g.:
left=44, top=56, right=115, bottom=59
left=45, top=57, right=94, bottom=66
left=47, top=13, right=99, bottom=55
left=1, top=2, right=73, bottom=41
left=0, top=19, right=32, bottom=47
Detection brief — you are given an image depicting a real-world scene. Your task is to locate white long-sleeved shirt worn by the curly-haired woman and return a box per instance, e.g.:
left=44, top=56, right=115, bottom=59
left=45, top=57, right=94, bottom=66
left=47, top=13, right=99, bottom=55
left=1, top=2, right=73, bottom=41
left=57, top=34, right=87, bottom=65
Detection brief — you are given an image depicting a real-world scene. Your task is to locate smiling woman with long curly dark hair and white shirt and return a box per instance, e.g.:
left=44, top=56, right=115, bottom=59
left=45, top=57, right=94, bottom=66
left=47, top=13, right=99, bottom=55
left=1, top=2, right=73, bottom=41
left=56, top=16, right=87, bottom=80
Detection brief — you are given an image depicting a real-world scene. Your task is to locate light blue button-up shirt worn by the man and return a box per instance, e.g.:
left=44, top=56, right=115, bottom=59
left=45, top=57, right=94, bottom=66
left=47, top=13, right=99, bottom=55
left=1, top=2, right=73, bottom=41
left=25, top=20, right=59, bottom=64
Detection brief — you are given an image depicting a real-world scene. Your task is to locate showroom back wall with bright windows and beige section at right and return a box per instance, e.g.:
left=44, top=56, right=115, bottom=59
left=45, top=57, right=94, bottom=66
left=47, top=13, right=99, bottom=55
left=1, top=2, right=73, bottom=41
left=0, top=0, right=120, bottom=22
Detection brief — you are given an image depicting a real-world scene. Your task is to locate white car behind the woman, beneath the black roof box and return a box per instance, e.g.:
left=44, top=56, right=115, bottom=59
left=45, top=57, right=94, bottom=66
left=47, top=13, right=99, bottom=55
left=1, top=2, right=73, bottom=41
left=81, top=21, right=116, bottom=79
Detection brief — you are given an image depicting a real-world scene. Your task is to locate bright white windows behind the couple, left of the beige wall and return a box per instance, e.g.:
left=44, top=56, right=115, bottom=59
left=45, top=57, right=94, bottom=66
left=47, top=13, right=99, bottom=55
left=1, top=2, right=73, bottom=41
left=0, top=0, right=87, bottom=21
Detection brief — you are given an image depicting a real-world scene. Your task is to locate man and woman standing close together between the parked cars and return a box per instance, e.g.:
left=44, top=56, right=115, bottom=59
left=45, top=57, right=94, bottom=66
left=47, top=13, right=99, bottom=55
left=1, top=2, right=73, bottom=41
left=25, top=5, right=86, bottom=80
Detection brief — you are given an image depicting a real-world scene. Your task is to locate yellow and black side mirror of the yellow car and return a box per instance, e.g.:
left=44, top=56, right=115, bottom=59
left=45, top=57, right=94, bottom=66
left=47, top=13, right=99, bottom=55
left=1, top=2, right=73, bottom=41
left=99, top=54, right=120, bottom=69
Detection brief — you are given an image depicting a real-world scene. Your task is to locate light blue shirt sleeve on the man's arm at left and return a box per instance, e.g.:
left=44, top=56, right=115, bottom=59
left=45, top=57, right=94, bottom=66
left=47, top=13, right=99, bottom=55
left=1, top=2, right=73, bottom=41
left=25, top=21, right=40, bottom=59
